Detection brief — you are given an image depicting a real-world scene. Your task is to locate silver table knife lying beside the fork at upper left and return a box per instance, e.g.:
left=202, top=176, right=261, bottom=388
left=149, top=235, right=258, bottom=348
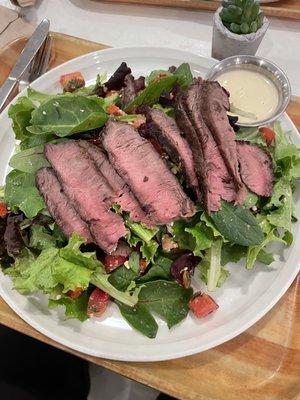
left=0, top=18, right=50, bottom=112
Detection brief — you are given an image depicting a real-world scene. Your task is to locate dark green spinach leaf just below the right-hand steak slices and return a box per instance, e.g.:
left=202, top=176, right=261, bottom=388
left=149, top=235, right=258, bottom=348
left=211, top=201, right=264, bottom=246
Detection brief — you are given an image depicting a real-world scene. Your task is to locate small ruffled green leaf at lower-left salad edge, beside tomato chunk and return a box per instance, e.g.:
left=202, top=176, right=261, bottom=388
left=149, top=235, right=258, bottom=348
left=48, top=291, right=89, bottom=322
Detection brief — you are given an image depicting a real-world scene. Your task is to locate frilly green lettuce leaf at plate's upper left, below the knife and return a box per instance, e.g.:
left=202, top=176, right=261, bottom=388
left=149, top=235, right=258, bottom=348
left=8, top=96, right=34, bottom=140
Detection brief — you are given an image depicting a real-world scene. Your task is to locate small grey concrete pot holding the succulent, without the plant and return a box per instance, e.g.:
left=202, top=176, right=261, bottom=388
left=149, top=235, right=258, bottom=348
left=211, top=7, right=269, bottom=60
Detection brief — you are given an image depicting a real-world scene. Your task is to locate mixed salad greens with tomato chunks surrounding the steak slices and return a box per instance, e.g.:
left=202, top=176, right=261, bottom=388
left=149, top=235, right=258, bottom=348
left=0, top=64, right=300, bottom=338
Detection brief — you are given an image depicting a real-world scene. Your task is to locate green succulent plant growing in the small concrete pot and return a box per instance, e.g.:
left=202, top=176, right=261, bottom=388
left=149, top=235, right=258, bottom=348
left=220, top=0, right=264, bottom=35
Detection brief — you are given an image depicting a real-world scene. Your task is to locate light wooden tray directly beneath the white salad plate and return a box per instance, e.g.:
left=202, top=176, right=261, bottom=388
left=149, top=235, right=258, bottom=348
left=0, top=34, right=300, bottom=400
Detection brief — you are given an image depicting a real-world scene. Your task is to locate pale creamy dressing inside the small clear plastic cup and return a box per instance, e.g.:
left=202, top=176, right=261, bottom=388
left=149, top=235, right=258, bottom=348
left=217, top=69, right=279, bottom=123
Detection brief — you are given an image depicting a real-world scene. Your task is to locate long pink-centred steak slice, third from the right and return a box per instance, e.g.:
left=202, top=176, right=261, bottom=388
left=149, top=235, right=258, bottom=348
left=176, top=81, right=236, bottom=212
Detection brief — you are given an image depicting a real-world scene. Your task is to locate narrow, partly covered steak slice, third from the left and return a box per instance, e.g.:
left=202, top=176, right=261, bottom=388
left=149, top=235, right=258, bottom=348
left=78, top=140, right=152, bottom=226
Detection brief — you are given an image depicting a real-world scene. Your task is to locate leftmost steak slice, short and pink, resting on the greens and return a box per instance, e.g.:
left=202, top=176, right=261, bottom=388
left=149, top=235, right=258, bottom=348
left=36, top=168, right=93, bottom=243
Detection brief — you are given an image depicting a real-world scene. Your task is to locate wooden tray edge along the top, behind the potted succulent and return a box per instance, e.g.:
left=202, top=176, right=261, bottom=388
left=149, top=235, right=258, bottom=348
left=104, top=0, right=300, bottom=19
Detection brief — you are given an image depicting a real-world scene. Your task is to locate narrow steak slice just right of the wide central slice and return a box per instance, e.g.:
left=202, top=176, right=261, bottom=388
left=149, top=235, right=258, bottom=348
left=146, top=108, right=200, bottom=198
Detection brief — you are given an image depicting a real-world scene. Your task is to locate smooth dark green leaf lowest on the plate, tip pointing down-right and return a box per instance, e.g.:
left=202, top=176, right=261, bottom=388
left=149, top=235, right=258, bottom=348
left=115, top=301, right=158, bottom=339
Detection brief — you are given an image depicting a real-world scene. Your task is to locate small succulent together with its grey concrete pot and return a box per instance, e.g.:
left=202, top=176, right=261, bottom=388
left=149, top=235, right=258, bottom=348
left=212, top=0, right=269, bottom=60
